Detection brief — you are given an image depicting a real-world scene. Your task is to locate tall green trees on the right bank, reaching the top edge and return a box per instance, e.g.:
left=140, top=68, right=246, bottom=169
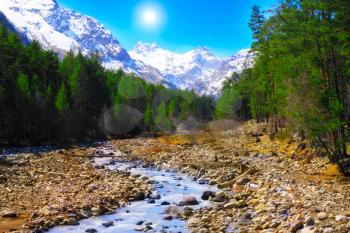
left=216, top=0, right=350, bottom=175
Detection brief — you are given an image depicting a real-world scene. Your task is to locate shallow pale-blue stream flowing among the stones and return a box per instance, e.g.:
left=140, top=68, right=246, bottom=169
left=49, top=148, right=217, bottom=233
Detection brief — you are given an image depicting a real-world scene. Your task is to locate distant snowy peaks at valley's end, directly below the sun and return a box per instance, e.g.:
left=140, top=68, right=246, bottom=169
left=129, top=42, right=254, bottom=95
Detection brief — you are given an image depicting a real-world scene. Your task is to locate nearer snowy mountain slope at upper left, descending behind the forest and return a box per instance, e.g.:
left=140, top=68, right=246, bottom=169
left=0, top=0, right=170, bottom=86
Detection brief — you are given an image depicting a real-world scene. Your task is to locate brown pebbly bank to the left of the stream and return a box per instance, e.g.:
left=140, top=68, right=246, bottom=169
left=0, top=147, right=150, bottom=232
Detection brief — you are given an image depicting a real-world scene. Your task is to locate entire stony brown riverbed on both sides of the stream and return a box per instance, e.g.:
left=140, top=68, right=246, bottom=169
left=0, top=122, right=350, bottom=233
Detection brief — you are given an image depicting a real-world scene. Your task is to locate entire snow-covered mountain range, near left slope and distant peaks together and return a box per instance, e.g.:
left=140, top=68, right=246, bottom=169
left=0, top=0, right=253, bottom=95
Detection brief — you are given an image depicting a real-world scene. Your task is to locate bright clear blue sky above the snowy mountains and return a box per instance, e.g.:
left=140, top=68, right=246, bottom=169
left=58, top=0, right=277, bottom=57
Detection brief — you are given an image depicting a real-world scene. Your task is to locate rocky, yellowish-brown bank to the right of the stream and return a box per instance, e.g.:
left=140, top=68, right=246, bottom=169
left=114, top=122, right=350, bottom=233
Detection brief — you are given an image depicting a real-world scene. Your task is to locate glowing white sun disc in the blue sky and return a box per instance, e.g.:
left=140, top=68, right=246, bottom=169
left=136, top=4, right=165, bottom=30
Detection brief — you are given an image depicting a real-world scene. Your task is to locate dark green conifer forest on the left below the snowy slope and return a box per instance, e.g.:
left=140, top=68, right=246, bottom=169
left=0, top=23, right=213, bottom=145
